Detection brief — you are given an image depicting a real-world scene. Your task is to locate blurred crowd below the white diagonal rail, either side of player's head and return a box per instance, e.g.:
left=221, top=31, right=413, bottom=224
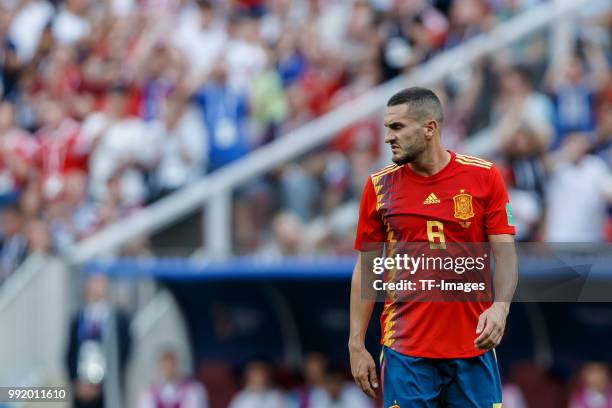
left=260, top=2, right=612, bottom=255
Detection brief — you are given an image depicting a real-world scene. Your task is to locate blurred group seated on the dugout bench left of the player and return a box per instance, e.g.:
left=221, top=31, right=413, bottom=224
left=138, top=350, right=375, bottom=408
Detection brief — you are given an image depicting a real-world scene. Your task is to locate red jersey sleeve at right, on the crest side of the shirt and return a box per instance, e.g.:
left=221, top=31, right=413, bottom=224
left=485, top=166, right=516, bottom=235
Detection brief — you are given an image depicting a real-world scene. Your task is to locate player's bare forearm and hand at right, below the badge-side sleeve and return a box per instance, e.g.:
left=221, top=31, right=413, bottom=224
left=474, top=234, right=518, bottom=350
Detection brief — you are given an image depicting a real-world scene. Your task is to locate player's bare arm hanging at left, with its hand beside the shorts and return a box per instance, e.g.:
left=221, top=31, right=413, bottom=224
left=348, top=252, right=380, bottom=398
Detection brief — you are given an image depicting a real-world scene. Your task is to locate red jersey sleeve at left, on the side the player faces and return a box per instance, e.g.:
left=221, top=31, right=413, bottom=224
left=355, top=177, right=385, bottom=251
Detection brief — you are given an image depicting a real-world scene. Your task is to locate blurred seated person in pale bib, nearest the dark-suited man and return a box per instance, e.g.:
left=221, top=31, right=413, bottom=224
left=138, top=350, right=208, bottom=408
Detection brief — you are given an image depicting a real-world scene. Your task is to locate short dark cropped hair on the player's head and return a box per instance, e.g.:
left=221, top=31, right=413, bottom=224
left=387, top=86, right=444, bottom=125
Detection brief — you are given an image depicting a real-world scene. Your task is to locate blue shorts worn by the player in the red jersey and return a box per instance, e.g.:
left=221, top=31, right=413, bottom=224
left=382, top=347, right=502, bottom=408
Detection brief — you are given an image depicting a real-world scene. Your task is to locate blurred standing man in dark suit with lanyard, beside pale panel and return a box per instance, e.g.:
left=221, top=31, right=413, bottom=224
left=66, top=274, right=131, bottom=408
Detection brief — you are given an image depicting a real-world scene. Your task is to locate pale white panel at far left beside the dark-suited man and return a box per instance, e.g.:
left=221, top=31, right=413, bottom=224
left=0, top=254, right=71, bottom=392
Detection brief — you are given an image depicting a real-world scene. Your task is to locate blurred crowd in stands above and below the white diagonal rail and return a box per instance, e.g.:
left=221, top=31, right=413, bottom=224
left=0, top=0, right=612, bottom=281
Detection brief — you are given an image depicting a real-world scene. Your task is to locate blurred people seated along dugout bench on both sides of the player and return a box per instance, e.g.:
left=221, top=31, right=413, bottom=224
left=138, top=349, right=612, bottom=408
